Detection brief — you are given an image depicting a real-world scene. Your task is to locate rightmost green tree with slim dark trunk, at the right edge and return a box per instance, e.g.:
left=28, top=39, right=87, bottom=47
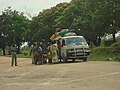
left=103, top=0, right=120, bottom=42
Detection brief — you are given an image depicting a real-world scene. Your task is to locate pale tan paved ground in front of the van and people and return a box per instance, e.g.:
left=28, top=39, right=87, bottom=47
left=0, top=57, right=120, bottom=90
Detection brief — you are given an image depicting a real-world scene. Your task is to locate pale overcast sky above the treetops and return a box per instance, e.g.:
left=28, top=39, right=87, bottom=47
left=0, top=0, right=71, bottom=16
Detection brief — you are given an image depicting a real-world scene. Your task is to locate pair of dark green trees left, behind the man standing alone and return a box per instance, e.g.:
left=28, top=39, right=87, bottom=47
left=0, top=7, right=29, bottom=55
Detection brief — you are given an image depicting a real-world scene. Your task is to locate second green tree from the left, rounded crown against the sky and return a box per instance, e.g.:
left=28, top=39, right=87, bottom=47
left=12, top=11, right=29, bottom=53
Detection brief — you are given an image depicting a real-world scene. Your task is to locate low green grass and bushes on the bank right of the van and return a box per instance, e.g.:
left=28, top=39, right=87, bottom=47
left=88, top=35, right=120, bottom=61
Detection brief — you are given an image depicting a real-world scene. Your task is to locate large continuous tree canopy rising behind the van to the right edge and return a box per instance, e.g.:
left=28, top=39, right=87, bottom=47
left=29, top=0, right=120, bottom=45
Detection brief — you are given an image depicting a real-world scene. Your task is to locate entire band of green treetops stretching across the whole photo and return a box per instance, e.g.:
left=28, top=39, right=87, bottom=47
left=0, top=0, right=120, bottom=54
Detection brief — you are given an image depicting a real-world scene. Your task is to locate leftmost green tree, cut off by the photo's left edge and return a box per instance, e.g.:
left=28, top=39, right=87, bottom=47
left=0, top=7, right=12, bottom=55
